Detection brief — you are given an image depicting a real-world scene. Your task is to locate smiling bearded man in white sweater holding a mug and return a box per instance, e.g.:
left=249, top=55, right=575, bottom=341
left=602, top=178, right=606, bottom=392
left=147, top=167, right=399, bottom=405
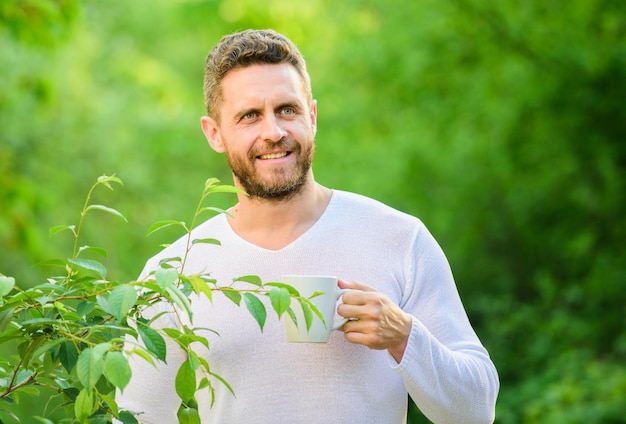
left=119, top=30, right=499, bottom=424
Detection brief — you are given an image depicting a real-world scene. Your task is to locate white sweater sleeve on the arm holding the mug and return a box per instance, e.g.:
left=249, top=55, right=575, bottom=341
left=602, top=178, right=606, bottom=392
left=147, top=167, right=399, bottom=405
left=389, top=225, right=499, bottom=424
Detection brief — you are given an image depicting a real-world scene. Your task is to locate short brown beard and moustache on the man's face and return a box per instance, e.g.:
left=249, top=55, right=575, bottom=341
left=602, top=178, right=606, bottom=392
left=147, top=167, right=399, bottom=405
left=226, top=137, right=315, bottom=201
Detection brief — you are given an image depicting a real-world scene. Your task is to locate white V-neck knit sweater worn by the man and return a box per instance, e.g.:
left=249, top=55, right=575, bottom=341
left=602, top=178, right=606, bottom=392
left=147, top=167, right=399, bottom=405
left=117, top=190, right=499, bottom=424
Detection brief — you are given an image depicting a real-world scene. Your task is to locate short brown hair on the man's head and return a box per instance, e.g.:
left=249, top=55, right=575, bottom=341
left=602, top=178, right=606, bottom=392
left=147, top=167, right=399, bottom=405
left=204, top=29, right=312, bottom=120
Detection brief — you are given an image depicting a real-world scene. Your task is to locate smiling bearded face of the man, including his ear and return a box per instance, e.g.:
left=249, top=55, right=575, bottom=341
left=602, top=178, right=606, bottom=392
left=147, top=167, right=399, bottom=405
left=202, top=64, right=317, bottom=200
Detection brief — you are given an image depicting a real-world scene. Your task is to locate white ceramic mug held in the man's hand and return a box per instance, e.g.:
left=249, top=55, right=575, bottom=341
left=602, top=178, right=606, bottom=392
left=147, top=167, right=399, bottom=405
left=282, top=275, right=348, bottom=343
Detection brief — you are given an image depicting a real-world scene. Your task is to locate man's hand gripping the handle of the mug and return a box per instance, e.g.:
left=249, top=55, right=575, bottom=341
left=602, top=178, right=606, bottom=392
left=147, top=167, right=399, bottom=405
left=337, top=280, right=412, bottom=363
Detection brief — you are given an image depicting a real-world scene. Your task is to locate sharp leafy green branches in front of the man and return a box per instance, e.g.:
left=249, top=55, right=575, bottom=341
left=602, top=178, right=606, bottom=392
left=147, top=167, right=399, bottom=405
left=0, top=176, right=319, bottom=423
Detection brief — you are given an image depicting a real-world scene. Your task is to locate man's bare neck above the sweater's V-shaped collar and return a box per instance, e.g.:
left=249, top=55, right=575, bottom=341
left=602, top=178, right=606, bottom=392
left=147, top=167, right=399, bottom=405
left=229, top=178, right=332, bottom=250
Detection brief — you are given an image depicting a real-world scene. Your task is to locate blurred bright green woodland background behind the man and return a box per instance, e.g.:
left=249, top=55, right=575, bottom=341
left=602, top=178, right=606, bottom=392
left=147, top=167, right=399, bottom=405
left=0, top=0, right=626, bottom=423
